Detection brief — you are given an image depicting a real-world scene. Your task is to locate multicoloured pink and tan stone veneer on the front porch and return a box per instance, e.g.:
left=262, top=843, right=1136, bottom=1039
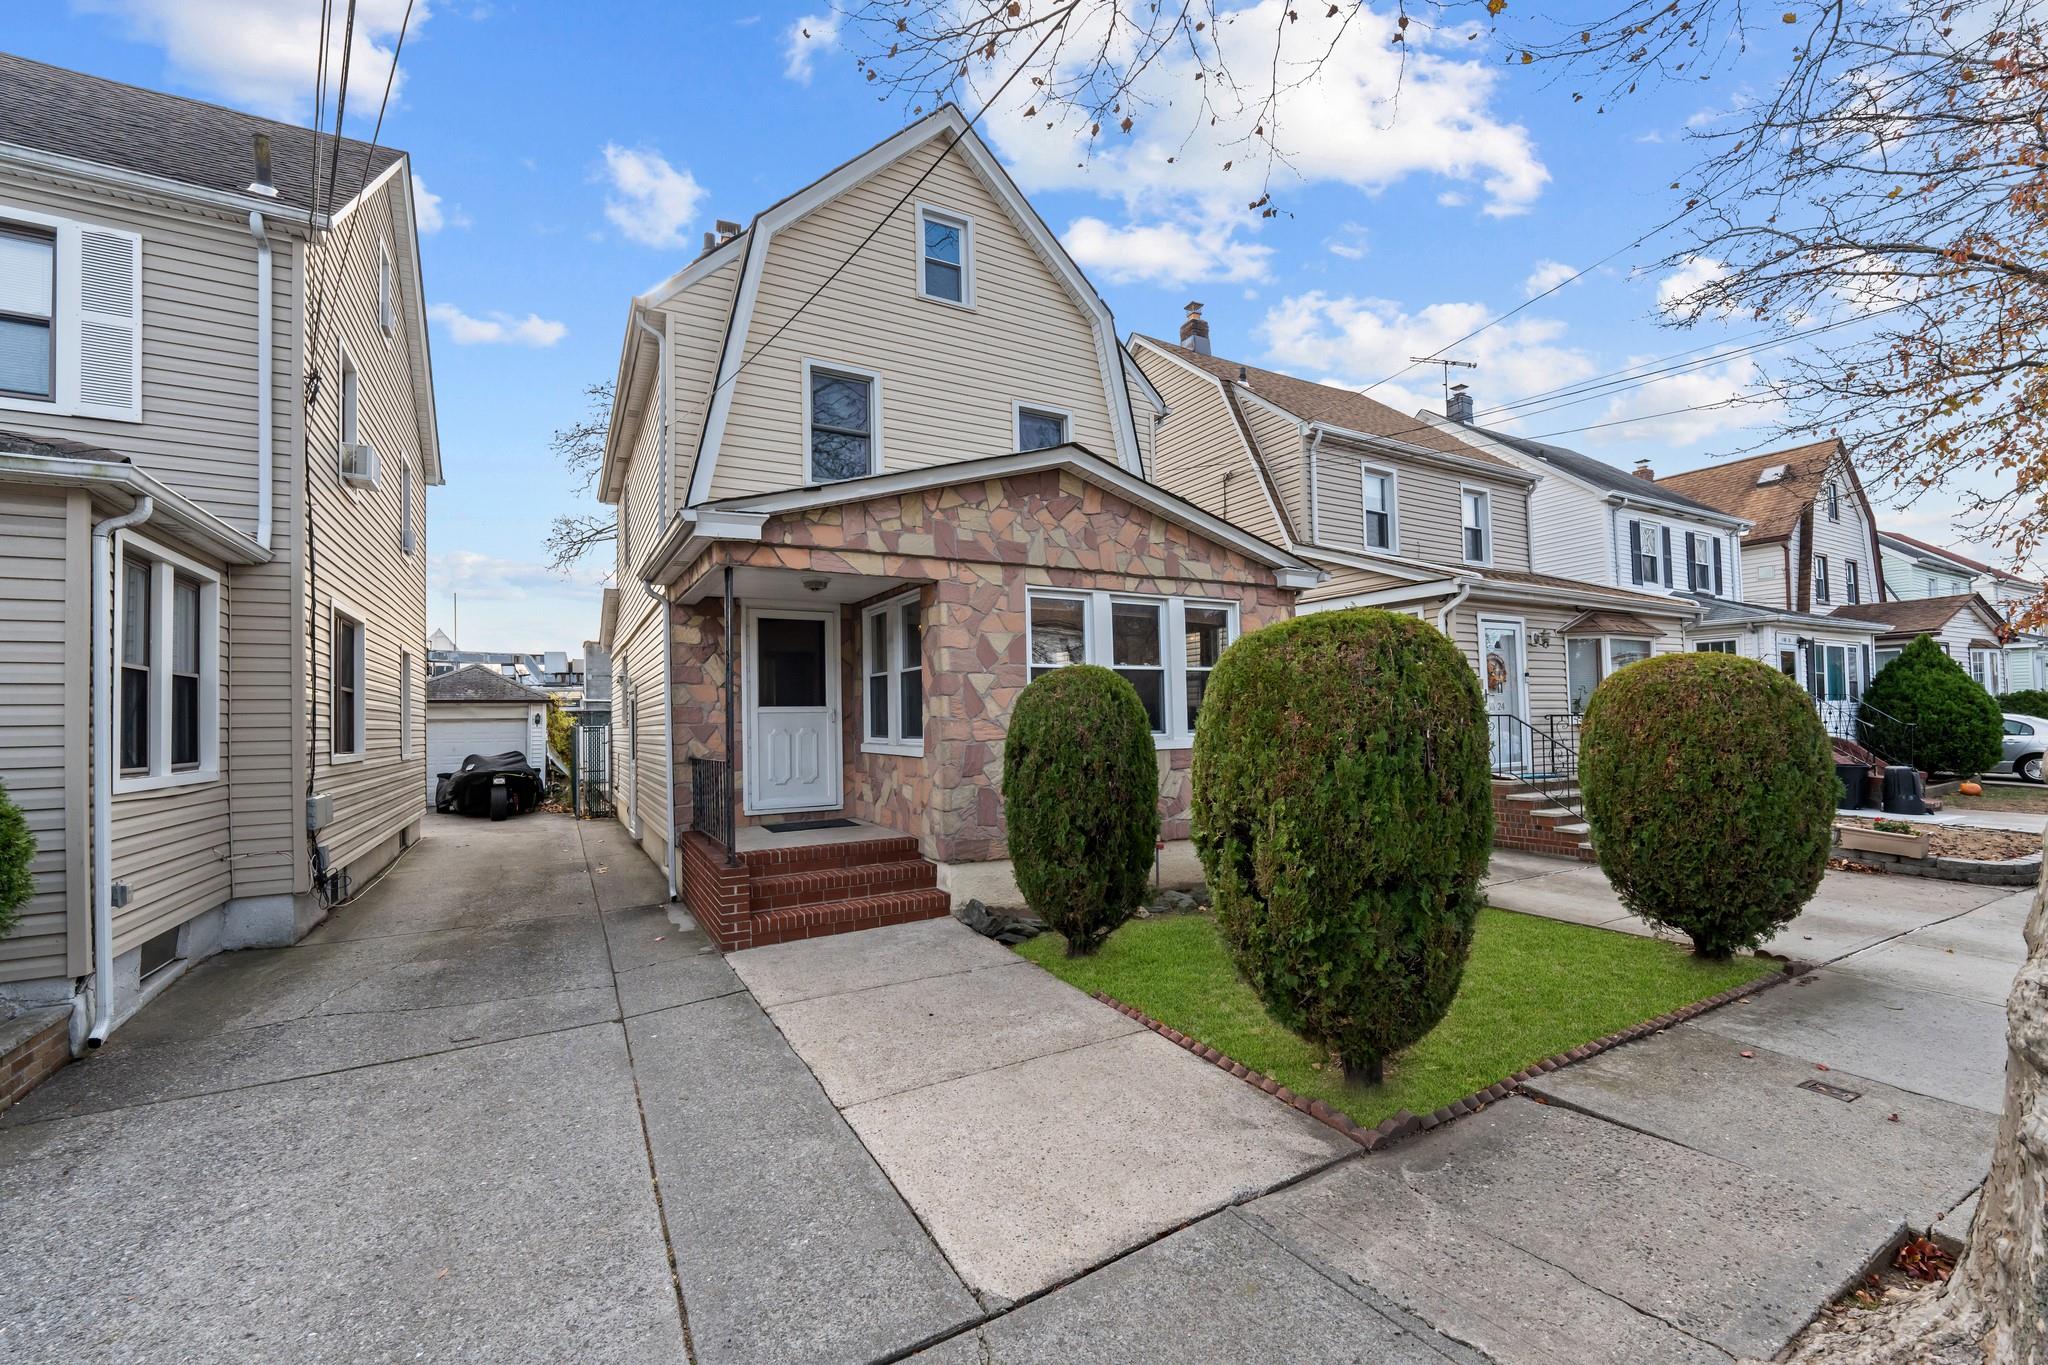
left=670, top=471, right=1294, bottom=862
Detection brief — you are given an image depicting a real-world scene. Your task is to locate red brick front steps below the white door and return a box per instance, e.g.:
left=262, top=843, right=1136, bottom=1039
left=682, top=833, right=952, bottom=952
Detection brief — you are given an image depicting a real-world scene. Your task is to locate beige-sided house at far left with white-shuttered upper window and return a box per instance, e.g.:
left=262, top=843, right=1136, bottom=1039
left=0, top=55, right=440, bottom=1044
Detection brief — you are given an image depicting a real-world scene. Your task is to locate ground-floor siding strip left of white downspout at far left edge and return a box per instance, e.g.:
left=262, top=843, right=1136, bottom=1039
left=0, top=485, right=90, bottom=982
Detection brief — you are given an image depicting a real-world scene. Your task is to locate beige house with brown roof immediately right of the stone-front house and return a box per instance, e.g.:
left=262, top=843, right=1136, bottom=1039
left=1130, top=305, right=1702, bottom=774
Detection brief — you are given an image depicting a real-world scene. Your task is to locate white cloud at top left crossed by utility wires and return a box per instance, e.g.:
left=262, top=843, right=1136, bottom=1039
left=72, top=0, right=430, bottom=127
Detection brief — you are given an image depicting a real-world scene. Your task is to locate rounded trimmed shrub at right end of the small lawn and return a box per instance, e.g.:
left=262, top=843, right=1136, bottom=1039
left=1579, top=653, right=1841, bottom=958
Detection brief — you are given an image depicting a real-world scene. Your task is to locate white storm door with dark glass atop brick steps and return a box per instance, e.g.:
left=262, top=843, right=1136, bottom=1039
left=741, top=608, right=842, bottom=814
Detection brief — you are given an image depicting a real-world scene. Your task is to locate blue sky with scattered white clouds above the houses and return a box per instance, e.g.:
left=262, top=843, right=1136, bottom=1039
left=4, top=0, right=1990, bottom=651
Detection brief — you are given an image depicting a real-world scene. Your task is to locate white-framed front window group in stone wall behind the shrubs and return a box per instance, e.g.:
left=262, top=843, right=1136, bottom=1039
left=1028, top=589, right=1237, bottom=749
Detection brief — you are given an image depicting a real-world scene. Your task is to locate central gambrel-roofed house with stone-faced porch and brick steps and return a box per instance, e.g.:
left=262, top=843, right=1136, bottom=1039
left=600, top=106, right=1317, bottom=948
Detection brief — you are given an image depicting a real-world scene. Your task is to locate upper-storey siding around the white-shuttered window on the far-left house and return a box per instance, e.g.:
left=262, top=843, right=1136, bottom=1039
left=0, top=172, right=276, bottom=532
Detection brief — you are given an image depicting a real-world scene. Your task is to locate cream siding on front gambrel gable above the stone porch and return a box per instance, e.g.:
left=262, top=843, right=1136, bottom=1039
left=711, top=145, right=1124, bottom=499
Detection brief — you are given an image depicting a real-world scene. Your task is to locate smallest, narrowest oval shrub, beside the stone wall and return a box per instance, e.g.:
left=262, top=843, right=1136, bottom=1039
left=1004, top=663, right=1159, bottom=956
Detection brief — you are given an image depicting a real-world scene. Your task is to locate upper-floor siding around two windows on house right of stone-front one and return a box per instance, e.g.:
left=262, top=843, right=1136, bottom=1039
left=1315, top=438, right=1530, bottom=569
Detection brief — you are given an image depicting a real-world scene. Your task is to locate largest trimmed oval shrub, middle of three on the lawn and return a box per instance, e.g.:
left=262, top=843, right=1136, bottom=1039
left=1192, top=610, right=1493, bottom=1083
